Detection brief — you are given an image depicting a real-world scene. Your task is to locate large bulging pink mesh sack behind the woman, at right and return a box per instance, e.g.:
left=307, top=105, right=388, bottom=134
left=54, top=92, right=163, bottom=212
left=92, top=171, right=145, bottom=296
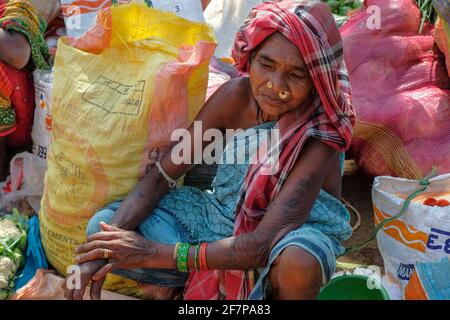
left=340, top=0, right=450, bottom=179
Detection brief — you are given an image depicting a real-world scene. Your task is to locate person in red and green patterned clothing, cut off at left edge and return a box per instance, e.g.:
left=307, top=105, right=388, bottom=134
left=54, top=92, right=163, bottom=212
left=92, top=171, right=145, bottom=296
left=0, top=0, right=50, bottom=181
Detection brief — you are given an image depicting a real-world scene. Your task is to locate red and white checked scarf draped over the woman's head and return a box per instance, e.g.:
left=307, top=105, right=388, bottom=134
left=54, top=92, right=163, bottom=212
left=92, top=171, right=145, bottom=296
left=184, top=0, right=356, bottom=300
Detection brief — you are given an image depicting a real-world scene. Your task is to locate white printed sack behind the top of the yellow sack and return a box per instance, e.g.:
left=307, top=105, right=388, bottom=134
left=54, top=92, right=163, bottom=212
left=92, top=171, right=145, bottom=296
left=61, top=0, right=204, bottom=38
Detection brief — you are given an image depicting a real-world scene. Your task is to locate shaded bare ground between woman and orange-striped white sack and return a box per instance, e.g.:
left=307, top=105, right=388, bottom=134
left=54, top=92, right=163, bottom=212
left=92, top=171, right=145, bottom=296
left=338, top=160, right=383, bottom=269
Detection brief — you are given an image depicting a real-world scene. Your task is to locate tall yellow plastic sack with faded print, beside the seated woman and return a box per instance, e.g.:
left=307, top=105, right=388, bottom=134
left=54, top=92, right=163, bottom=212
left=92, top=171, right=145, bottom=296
left=39, top=5, right=215, bottom=292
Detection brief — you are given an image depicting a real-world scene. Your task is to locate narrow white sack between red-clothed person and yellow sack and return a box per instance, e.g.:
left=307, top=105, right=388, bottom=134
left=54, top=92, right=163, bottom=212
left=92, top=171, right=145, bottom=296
left=31, top=70, right=53, bottom=159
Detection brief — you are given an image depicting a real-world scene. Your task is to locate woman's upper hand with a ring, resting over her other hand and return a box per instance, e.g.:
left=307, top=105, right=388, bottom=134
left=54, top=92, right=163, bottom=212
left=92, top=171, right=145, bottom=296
left=75, top=222, right=157, bottom=280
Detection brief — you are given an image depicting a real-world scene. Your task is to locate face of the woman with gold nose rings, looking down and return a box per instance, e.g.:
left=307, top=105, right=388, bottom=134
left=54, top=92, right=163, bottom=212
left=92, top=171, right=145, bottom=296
left=250, top=32, right=313, bottom=118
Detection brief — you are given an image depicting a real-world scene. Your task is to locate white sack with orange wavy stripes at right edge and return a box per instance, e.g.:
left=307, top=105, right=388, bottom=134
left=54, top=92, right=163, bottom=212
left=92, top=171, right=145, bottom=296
left=372, top=174, right=450, bottom=297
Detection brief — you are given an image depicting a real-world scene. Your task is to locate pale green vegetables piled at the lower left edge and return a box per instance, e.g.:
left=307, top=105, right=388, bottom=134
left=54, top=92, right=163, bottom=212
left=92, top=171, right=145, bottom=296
left=0, top=209, right=28, bottom=300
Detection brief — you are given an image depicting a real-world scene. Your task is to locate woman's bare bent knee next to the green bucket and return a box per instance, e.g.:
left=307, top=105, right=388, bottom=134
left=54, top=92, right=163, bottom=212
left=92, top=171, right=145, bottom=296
left=269, top=246, right=322, bottom=300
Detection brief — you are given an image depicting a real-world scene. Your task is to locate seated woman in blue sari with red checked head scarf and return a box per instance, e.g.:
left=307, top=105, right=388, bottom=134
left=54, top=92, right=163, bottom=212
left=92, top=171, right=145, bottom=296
left=66, top=0, right=355, bottom=299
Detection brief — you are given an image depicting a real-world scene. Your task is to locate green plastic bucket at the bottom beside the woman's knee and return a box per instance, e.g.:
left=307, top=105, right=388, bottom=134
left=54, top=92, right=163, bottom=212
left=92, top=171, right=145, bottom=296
left=317, top=274, right=389, bottom=300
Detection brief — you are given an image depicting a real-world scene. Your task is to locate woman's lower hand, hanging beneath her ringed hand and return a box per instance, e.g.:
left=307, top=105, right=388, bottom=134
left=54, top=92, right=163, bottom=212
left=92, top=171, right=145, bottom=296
left=63, top=259, right=107, bottom=300
